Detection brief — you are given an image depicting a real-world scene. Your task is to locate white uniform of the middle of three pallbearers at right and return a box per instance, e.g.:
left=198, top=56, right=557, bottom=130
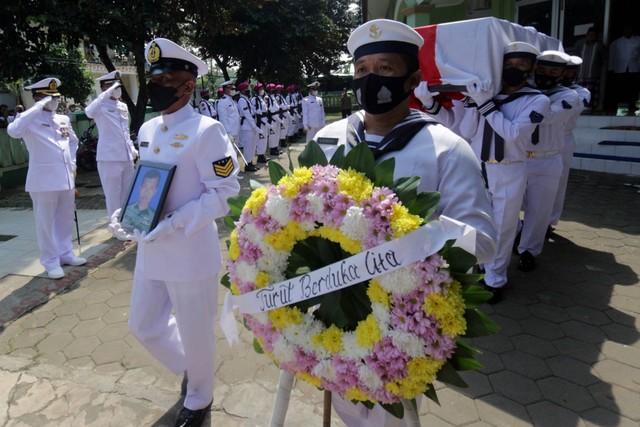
left=518, top=85, right=581, bottom=257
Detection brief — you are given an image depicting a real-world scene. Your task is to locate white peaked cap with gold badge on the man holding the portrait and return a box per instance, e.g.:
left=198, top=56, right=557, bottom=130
left=144, top=38, right=209, bottom=77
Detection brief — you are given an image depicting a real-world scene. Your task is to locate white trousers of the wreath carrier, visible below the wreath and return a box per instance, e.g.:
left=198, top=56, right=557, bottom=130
left=331, top=393, right=422, bottom=427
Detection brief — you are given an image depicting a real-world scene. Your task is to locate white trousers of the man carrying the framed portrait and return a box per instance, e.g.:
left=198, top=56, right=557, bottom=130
left=129, top=269, right=218, bottom=410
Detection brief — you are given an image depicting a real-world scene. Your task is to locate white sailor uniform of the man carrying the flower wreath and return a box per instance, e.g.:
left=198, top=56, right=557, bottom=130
left=317, top=111, right=496, bottom=427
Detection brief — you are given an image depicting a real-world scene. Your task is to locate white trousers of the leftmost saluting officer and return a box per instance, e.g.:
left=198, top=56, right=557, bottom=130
left=29, top=189, right=76, bottom=271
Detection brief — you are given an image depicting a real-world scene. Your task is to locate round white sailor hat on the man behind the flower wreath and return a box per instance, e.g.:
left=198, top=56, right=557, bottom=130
left=347, top=19, right=424, bottom=60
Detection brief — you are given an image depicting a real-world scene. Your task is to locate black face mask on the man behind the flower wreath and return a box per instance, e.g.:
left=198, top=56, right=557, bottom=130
left=352, top=73, right=411, bottom=114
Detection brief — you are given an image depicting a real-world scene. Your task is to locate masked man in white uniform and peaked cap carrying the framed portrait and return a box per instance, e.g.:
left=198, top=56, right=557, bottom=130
left=110, top=38, right=240, bottom=427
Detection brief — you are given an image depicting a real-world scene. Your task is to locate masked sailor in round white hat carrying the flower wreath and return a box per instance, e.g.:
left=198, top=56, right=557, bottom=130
left=317, top=19, right=495, bottom=427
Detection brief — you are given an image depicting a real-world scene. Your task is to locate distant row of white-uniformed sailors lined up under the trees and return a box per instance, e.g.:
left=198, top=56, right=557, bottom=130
left=198, top=80, right=325, bottom=172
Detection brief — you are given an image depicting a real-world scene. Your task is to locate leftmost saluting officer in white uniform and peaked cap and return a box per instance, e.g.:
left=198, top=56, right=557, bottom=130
left=7, top=77, right=87, bottom=279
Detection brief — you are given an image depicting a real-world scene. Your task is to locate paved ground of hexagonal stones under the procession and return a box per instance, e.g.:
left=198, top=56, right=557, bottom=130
left=0, top=144, right=640, bottom=427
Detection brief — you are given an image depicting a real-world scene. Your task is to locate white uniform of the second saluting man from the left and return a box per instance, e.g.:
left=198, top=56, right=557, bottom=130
left=85, top=92, right=138, bottom=217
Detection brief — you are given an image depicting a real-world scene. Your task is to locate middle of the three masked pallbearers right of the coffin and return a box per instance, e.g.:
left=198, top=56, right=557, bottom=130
left=517, top=50, right=580, bottom=271
